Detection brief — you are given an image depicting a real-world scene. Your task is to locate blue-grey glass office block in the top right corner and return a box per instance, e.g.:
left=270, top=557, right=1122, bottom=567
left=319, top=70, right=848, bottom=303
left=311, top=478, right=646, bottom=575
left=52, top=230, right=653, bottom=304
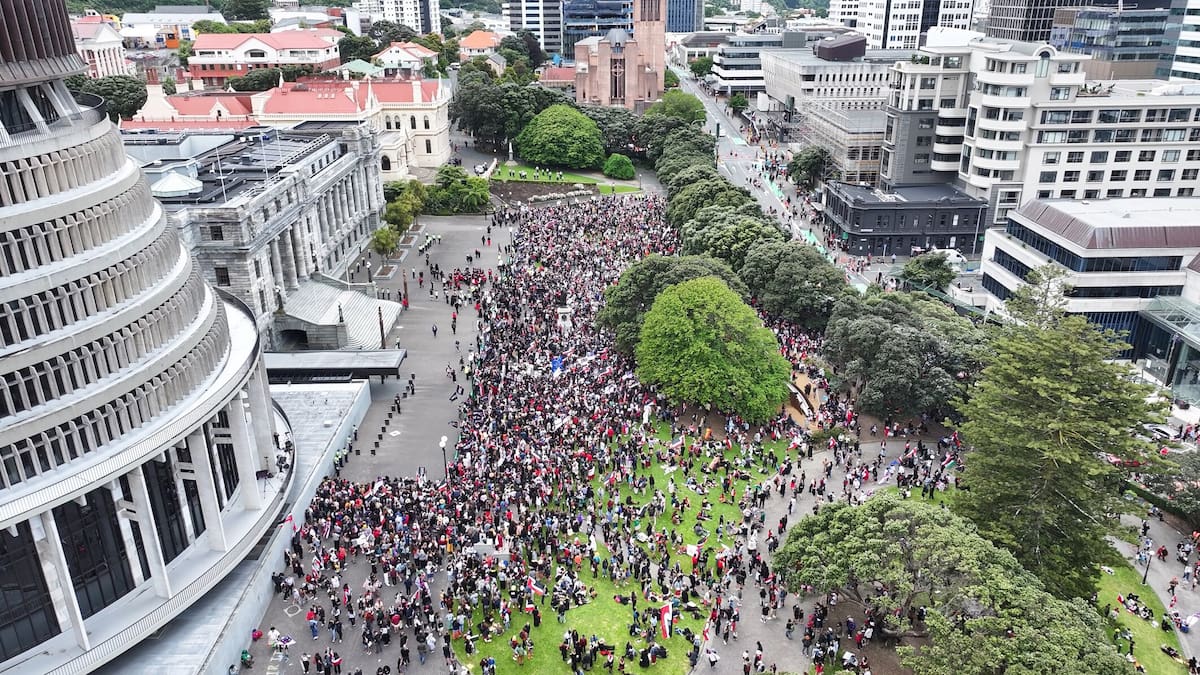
left=1050, top=2, right=1174, bottom=79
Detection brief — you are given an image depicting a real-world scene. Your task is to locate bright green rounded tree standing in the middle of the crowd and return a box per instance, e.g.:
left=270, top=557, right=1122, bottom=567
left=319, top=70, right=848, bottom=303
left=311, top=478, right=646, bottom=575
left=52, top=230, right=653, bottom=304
left=635, top=276, right=792, bottom=422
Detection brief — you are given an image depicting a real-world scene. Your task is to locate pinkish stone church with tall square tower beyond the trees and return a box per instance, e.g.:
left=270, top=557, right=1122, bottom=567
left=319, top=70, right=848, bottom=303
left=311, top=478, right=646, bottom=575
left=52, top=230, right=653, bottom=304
left=575, top=0, right=666, bottom=110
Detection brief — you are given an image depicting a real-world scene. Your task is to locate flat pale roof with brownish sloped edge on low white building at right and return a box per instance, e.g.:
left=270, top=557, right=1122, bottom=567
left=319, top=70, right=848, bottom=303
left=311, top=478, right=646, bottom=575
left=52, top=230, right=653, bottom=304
left=1016, top=197, right=1200, bottom=250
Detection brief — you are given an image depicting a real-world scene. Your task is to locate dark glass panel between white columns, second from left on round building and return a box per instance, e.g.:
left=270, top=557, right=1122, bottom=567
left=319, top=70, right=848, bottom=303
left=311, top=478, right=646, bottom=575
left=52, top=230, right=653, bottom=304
left=54, top=488, right=134, bottom=619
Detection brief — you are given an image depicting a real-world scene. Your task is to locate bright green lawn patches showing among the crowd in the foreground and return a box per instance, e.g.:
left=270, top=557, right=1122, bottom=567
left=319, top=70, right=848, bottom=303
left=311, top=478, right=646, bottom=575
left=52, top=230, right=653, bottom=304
left=455, top=425, right=786, bottom=675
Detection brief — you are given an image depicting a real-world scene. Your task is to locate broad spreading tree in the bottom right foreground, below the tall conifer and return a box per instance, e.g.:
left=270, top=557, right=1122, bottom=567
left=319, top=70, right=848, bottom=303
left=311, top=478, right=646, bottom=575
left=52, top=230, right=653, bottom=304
left=774, top=495, right=1132, bottom=675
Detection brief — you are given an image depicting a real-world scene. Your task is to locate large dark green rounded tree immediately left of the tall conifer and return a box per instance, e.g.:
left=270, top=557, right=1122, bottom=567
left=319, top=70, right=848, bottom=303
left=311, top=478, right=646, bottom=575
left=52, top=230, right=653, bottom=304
left=823, top=288, right=984, bottom=417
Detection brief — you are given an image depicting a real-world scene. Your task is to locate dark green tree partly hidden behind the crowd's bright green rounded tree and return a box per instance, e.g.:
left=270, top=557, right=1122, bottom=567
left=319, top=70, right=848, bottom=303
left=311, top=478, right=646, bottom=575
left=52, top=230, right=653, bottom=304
left=596, top=253, right=750, bottom=356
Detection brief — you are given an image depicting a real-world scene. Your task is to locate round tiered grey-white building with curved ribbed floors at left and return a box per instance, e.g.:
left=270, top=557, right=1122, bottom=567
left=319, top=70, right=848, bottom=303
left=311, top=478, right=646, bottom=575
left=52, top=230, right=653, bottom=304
left=0, top=0, right=292, bottom=673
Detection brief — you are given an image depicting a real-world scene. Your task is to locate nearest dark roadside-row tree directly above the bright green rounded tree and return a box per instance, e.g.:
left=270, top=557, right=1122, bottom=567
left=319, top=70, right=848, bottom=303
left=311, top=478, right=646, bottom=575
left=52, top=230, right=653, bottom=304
left=679, top=203, right=784, bottom=270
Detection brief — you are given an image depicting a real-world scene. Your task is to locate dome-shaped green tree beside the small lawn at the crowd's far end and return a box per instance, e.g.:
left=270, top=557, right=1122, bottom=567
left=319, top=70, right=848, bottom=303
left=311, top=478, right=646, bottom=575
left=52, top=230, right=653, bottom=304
left=516, top=104, right=604, bottom=168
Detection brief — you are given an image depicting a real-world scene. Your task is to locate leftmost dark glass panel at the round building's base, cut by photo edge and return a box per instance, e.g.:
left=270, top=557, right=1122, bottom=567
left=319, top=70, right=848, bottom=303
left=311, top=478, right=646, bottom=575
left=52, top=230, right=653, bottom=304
left=0, top=522, right=59, bottom=661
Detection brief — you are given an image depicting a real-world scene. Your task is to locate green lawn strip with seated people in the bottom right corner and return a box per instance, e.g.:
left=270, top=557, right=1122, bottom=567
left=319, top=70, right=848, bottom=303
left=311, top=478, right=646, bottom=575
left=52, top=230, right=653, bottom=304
left=1097, top=563, right=1187, bottom=675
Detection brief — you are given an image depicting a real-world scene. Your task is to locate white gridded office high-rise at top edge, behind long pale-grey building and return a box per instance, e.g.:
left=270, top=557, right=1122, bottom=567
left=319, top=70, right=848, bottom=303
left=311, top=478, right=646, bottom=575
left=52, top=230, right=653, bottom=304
left=829, top=0, right=972, bottom=49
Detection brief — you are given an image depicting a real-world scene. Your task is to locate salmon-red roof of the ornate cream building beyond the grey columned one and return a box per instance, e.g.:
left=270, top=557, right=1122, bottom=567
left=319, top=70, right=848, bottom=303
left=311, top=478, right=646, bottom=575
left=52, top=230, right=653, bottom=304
left=263, top=79, right=438, bottom=115
